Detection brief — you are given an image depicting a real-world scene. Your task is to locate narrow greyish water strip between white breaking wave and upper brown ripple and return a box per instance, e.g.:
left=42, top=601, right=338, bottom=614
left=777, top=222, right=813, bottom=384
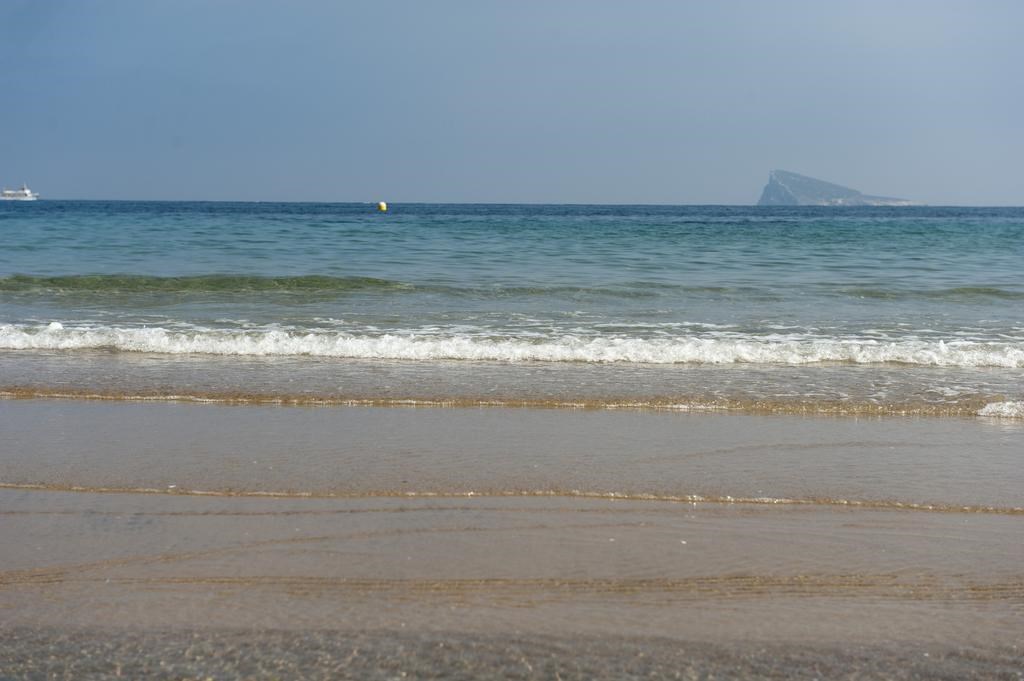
left=0, top=350, right=1024, bottom=421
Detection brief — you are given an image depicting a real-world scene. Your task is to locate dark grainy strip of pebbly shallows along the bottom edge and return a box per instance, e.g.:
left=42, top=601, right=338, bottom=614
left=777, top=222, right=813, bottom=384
left=0, top=628, right=1020, bottom=681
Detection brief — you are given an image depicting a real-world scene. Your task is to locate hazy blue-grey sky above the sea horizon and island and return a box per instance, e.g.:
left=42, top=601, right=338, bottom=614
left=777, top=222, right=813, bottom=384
left=0, top=0, right=1024, bottom=206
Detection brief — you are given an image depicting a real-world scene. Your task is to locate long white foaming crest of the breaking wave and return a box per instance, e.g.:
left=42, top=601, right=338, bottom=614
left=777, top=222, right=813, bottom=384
left=0, top=323, right=1024, bottom=369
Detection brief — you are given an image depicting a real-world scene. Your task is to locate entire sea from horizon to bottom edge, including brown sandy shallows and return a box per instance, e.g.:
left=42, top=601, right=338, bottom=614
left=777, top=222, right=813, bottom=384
left=0, top=201, right=1024, bottom=681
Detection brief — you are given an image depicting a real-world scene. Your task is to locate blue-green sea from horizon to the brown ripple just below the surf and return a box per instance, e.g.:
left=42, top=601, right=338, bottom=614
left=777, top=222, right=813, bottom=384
left=0, top=201, right=1024, bottom=418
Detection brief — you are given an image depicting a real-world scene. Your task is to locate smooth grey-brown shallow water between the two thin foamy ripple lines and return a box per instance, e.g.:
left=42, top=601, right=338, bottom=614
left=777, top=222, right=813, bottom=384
left=0, top=400, right=1024, bottom=513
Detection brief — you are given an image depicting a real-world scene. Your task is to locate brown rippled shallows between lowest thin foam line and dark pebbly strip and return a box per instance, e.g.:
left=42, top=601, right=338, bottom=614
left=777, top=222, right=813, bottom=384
left=0, top=483, right=1024, bottom=655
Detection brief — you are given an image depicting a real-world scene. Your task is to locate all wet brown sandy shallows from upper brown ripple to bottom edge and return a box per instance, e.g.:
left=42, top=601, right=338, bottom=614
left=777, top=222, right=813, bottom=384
left=0, top=400, right=1024, bottom=679
